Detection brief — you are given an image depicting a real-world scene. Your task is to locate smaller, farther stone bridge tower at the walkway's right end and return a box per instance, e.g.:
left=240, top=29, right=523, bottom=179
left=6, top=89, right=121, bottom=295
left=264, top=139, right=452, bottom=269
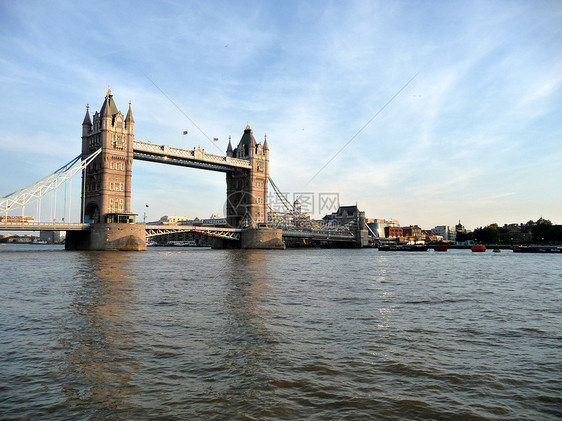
left=226, top=124, right=269, bottom=228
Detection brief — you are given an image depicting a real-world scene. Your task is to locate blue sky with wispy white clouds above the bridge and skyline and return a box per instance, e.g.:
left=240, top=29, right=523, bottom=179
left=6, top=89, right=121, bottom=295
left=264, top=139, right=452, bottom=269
left=0, top=1, right=562, bottom=228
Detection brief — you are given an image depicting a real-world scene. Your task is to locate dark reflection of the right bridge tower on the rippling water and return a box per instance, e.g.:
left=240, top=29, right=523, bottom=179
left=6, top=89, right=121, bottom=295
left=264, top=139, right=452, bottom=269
left=188, top=250, right=277, bottom=419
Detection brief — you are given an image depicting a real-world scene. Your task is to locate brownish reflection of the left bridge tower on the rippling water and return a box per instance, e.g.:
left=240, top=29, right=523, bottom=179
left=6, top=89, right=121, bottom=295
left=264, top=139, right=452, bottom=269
left=61, top=252, right=140, bottom=417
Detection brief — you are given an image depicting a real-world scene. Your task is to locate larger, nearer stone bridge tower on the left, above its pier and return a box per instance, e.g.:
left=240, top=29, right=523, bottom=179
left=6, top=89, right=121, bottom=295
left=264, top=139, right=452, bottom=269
left=81, top=89, right=135, bottom=223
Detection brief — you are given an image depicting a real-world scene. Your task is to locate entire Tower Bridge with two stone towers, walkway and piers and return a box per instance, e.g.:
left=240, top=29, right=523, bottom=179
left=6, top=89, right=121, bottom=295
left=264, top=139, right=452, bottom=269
left=0, top=89, right=368, bottom=250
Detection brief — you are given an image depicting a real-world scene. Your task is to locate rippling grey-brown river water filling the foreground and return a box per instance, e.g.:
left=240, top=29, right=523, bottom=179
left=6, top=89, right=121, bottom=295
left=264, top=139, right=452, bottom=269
left=0, top=245, right=562, bottom=420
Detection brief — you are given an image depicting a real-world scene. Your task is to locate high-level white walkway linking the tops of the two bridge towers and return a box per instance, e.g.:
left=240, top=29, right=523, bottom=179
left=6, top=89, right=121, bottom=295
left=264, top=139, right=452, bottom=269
left=133, top=140, right=248, bottom=172
